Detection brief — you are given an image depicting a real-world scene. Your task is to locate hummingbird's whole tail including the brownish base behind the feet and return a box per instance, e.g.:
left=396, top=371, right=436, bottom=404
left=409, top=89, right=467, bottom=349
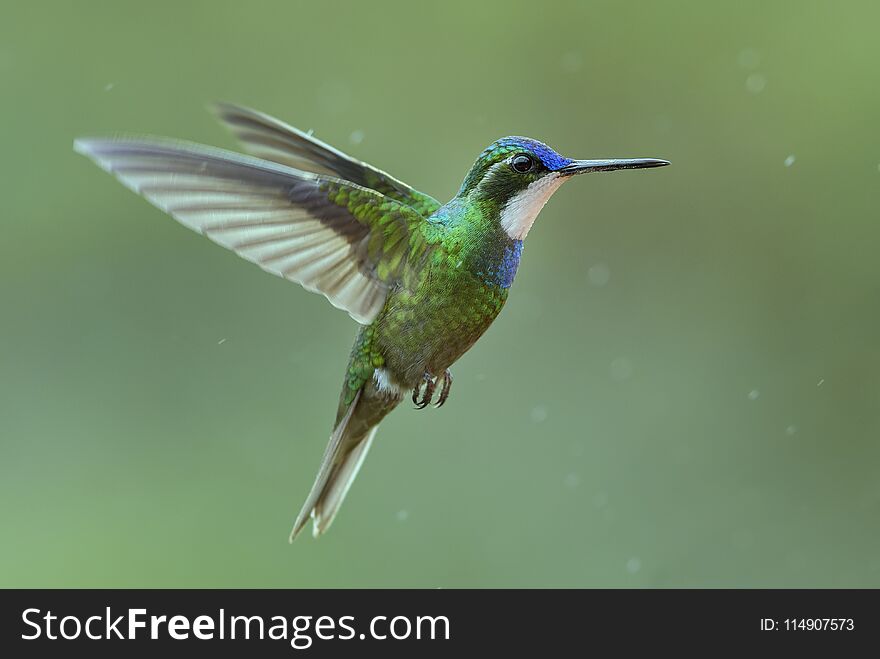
left=290, top=381, right=399, bottom=542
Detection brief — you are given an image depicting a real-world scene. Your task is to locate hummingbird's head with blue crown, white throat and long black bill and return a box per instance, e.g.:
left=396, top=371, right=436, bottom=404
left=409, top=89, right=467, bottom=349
left=458, top=137, right=669, bottom=240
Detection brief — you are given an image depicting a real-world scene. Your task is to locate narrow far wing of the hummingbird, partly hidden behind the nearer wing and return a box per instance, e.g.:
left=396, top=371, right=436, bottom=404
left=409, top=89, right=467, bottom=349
left=213, top=103, right=440, bottom=217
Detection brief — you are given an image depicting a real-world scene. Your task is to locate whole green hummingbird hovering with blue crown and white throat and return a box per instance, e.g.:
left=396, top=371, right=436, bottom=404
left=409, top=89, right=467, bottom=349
left=74, top=103, right=669, bottom=542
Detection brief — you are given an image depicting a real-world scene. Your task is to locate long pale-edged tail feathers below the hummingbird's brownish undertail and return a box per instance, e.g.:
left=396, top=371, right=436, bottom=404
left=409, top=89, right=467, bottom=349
left=289, top=390, right=376, bottom=542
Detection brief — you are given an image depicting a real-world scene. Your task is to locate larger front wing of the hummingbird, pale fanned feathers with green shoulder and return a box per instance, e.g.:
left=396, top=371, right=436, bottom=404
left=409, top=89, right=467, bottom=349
left=74, top=138, right=430, bottom=324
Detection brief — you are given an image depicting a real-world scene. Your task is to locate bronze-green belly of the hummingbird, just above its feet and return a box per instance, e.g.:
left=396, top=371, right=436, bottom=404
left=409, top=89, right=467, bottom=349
left=377, top=276, right=507, bottom=388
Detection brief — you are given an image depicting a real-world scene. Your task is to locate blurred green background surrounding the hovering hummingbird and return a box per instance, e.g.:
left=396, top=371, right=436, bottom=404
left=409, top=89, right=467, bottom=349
left=0, top=1, right=880, bottom=587
